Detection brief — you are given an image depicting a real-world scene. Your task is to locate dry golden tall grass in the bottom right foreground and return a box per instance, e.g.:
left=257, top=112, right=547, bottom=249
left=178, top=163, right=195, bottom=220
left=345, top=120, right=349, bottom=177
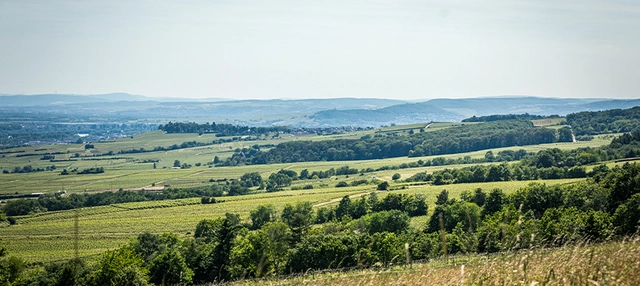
left=236, top=237, right=640, bottom=286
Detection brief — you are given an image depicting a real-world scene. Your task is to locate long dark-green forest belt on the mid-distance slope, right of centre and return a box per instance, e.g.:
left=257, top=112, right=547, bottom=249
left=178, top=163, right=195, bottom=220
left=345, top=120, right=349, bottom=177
left=221, top=120, right=572, bottom=165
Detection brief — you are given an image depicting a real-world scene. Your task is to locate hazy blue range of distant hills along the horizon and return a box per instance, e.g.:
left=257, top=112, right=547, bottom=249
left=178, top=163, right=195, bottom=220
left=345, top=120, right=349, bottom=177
left=0, top=93, right=640, bottom=127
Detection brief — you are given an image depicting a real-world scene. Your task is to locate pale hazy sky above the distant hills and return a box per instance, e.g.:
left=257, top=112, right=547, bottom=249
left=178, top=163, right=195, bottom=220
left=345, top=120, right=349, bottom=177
left=0, top=0, right=640, bottom=100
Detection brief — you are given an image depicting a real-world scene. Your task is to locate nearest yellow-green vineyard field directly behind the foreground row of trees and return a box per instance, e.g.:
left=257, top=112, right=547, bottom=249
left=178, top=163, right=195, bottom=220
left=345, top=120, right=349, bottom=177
left=0, top=179, right=578, bottom=262
